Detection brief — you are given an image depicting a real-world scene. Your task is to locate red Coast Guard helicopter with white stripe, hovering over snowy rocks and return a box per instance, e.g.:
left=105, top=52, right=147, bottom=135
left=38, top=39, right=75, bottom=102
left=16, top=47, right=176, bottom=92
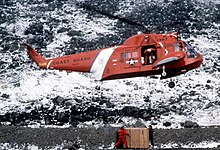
left=22, top=3, right=203, bottom=87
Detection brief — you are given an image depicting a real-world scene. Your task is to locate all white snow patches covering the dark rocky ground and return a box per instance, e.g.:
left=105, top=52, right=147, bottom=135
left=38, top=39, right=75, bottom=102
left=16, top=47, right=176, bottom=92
left=0, top=0, right=220, bottom=150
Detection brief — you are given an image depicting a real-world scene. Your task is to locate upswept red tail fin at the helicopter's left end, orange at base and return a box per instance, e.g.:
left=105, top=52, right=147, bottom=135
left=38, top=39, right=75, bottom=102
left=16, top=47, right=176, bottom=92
left=21, top=43, right=48, bottom=68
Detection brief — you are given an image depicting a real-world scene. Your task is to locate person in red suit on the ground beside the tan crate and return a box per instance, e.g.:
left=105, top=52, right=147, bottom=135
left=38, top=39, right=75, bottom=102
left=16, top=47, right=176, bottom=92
left=114, top=126, right=130, bottom=148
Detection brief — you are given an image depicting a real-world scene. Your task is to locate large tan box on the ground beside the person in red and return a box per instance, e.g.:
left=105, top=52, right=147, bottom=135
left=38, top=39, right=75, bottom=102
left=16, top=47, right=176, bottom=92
left=125, top=128, right=149, bottom=149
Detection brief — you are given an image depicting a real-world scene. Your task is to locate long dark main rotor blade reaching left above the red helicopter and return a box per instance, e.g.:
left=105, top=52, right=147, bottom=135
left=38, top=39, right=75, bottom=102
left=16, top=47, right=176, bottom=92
left=76, top=3, right=150, bottom=33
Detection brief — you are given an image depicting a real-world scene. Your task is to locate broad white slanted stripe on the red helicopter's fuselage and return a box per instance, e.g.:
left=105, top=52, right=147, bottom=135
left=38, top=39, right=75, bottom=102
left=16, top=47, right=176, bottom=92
left=90, top=47, right=117, bottom=80
